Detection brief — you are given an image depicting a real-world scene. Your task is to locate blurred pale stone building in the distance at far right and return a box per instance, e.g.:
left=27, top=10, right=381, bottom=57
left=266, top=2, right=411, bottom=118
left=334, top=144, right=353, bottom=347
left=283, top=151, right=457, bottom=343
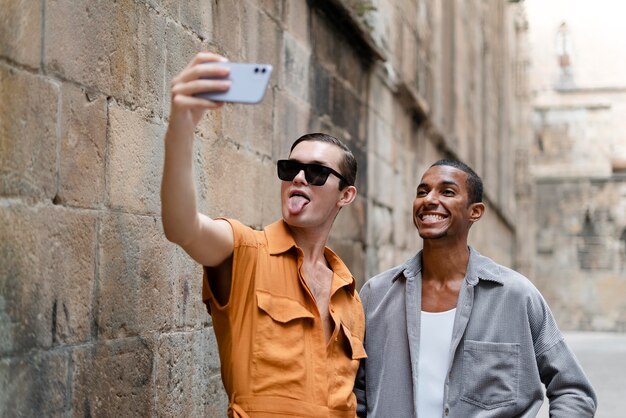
left=527, top=0, right=626, bottom=332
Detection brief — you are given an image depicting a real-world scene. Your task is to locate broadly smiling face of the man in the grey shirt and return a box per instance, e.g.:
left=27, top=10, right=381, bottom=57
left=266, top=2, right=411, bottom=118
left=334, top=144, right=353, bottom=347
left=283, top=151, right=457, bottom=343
left=413, top=165, right=485, bottom=245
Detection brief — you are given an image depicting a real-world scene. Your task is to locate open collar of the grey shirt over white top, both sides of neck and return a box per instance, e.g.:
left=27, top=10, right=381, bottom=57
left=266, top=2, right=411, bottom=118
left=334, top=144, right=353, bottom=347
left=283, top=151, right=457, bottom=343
left=392, top=246, right=504, bottom=286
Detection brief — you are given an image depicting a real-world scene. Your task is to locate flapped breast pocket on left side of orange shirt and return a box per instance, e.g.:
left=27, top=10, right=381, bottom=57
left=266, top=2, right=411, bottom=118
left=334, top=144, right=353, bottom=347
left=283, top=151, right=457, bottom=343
left=252, top=290, right=314, bottom=393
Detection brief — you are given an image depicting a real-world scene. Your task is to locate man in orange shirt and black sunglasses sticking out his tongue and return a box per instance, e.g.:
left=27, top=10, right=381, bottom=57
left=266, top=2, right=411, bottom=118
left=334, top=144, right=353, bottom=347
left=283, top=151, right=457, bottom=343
left=161, top=53, right=365, bottom=418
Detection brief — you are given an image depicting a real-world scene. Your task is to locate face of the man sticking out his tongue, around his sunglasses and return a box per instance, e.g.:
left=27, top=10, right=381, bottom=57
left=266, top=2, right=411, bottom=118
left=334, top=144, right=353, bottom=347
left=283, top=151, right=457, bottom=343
left=281, top=141, right=356, bottom=229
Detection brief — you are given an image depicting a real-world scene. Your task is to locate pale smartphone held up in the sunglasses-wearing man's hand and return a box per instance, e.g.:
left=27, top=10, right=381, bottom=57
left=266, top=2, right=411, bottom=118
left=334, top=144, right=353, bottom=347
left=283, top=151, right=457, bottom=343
left=197, top=62, right=272, bottom=104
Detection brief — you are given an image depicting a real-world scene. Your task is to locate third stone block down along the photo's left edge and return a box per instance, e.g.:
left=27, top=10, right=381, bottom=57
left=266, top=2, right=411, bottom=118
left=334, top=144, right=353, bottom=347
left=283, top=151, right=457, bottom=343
left=0, top=203, right=96, bottom=355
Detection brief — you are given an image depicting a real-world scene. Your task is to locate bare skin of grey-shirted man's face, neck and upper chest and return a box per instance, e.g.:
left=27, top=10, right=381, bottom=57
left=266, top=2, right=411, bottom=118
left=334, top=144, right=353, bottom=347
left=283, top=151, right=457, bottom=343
left=413, top=166, right=485, bottom=312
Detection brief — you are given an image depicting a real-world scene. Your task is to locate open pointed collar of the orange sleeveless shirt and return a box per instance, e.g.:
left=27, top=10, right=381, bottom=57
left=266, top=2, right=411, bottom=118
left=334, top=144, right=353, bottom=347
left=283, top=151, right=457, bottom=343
left=265, top=219, right=356, bottom=295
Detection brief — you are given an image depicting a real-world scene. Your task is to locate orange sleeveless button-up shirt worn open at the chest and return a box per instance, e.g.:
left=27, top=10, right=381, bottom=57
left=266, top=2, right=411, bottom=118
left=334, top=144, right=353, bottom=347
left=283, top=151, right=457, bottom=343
left=202, top=219, right=366, bottom=418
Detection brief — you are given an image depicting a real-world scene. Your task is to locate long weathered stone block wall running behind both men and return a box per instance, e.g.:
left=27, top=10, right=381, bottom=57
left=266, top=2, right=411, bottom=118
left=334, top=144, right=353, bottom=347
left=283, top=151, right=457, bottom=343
left=0, top=0, right=533, bottom=417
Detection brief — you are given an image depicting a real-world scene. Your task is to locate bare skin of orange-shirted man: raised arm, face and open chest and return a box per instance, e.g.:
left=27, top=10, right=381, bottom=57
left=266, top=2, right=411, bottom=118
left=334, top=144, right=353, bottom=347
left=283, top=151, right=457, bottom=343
left=161, top=52, right=356, bottom=340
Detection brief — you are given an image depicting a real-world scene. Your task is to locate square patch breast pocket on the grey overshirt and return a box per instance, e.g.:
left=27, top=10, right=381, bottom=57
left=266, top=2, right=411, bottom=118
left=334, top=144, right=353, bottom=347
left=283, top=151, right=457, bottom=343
left=461, top=340, right=520, bottom=409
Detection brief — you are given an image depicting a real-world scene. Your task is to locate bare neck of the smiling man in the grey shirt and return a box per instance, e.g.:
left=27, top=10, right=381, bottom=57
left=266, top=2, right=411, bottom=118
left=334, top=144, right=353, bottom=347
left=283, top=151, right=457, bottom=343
left=422, top=240, right=469, bottom=282
